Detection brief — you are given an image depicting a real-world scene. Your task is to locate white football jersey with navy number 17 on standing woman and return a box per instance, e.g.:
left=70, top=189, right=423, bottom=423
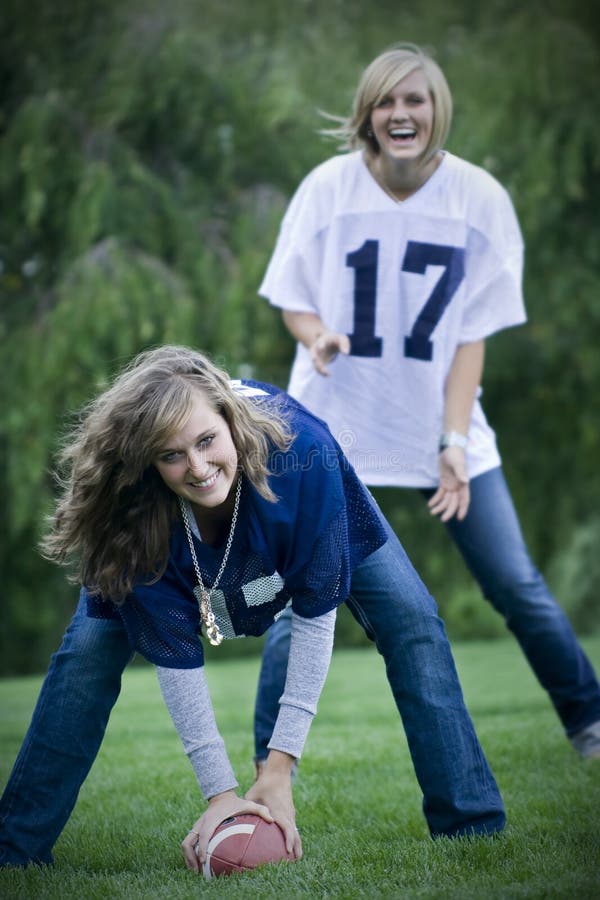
left=259, top=152, right=526, bottom=487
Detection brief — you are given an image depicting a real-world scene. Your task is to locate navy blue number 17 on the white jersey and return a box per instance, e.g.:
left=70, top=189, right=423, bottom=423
left=346, top=241, right=465, bottom=361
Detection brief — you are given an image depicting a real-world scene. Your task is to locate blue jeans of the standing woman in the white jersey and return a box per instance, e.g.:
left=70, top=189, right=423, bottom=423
left=255, top=468, right=600, bottom=768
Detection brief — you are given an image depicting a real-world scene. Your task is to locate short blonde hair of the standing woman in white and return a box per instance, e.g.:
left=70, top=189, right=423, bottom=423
left=321, top=44, right=452, bottom=160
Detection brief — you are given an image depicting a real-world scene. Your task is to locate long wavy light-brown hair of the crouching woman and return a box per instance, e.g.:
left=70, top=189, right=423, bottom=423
left=41, top=346, right=293, bottom=603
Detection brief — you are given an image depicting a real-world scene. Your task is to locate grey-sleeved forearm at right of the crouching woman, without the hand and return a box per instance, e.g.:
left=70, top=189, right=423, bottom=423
left=269, top=610, right=336, bottom=758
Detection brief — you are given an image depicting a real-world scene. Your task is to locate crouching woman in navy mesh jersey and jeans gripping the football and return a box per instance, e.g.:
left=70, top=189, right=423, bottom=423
left=0, top=347, right=505, bottom=870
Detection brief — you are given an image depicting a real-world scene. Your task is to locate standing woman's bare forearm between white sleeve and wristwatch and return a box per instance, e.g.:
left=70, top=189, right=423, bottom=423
left=443, top=341, right=485, bottom=435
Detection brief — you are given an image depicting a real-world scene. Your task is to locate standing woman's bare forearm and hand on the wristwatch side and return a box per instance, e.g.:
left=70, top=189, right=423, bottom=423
left=429, top=341, right=485, bottom=522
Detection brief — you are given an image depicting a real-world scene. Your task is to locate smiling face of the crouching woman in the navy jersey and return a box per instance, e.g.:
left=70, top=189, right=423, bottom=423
left=154, top=390, right=238, bottom=511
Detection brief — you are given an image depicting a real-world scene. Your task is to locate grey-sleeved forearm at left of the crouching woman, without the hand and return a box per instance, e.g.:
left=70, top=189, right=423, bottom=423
left=156, top=666, right=237, bottom=799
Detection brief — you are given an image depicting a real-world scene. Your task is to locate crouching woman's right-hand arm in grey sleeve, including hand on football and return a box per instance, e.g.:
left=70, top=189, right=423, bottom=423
left=246, top=609, right=336, bottom=858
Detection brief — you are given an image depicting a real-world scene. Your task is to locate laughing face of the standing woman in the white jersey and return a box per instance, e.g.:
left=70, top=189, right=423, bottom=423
left=371, top=69, right=434, bottom=163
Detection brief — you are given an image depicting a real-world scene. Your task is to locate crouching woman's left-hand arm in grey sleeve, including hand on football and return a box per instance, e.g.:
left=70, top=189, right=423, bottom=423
left=156, top=666, right=273, bottom=871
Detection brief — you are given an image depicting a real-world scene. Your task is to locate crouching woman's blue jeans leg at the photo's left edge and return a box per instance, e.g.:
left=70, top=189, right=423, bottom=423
left=0, top=599, right=132, bottom=866
